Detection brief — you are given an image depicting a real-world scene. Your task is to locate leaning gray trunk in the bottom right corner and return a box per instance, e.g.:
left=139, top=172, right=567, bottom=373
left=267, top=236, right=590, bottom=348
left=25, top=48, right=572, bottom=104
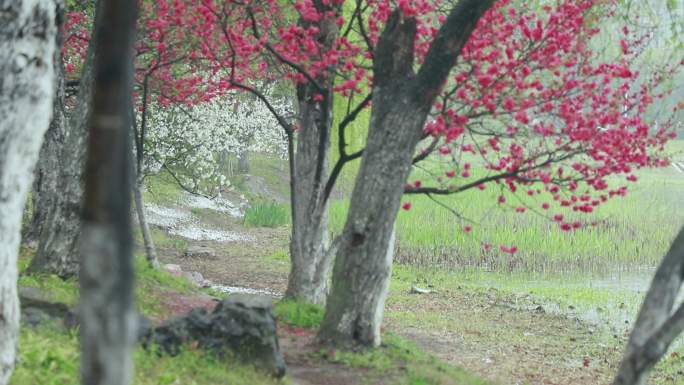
left=613, top=228, right=684, bottom=385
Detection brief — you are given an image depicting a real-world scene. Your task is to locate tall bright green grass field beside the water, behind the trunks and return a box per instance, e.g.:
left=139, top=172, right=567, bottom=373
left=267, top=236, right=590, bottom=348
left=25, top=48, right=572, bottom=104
left=330, top=160, right=684, bottom=273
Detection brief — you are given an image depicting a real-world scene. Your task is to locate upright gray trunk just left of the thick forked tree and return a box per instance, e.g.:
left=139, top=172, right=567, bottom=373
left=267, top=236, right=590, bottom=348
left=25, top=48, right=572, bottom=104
left=285, top=1, right=339, bottom=305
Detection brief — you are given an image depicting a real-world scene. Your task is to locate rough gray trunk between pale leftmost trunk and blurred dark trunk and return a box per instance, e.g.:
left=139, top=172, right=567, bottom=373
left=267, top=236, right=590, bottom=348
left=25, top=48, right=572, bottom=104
left=29, top=6, right=99, bottom=278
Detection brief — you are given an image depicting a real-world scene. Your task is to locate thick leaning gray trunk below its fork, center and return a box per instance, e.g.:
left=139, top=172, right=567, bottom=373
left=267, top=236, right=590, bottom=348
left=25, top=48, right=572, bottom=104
left=319, top=89, right=427, bottom=348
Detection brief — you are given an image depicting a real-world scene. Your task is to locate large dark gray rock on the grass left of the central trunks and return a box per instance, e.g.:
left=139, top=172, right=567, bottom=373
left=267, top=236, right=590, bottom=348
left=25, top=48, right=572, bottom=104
left=142, top=294, right=286, bottom=377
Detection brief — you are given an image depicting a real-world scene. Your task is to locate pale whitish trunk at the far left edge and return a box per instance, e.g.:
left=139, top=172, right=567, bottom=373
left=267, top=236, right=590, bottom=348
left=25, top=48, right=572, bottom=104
left=0, top=0, right=57, bottom=385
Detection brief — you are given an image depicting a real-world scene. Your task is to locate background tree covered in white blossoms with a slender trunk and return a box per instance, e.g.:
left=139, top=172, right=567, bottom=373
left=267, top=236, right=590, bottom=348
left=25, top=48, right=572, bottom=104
left=134, top=87, right=293, bottom=266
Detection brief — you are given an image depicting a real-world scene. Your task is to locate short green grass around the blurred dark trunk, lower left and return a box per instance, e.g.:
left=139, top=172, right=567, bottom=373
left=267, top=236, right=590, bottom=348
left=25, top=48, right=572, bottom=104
left=10, top=249, right=287, bottom=385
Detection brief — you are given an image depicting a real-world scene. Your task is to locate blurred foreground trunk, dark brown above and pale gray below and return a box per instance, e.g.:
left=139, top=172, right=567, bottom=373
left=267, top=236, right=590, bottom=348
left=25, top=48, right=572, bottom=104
left=80, top=0, right=137, bottom=385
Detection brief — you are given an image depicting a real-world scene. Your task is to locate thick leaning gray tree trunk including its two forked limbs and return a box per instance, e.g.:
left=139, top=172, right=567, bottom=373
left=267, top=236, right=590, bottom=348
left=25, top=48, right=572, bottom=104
left=319, top=0, right=494, bottom=348
